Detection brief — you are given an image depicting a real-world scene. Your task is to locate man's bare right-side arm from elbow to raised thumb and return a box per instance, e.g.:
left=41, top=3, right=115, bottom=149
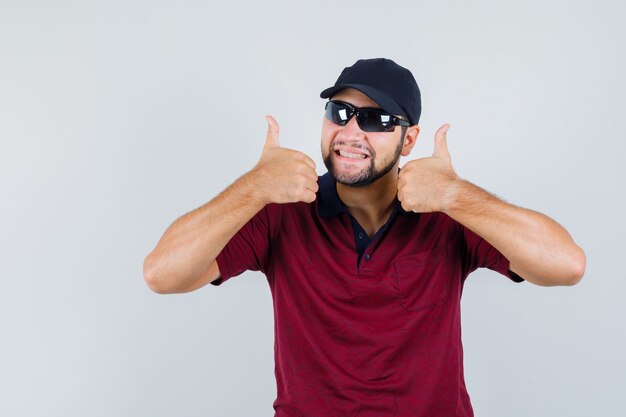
left=398, top=125, right=586, bottom=286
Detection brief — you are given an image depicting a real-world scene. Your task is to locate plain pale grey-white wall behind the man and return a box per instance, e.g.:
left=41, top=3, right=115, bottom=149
left=0, top=0, right=626, bottom=417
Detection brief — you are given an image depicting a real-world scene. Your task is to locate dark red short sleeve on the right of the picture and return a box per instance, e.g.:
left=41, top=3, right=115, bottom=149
left=459, top=224, right=524, bottom=282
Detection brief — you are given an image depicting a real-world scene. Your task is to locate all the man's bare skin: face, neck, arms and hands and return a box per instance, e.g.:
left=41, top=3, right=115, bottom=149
left=144, top=89, right=586, bottom=294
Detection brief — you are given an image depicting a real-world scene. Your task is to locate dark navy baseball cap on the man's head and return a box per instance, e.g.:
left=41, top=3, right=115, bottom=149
left=320, top=58, right=422, bottom=125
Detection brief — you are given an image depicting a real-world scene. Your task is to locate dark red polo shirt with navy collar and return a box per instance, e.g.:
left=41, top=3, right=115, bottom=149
left=212, top=174, right=523, bottom=417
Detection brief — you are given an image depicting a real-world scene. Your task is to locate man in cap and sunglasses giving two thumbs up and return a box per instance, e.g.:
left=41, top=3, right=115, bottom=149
left=144, top=58, right=585, bottom=417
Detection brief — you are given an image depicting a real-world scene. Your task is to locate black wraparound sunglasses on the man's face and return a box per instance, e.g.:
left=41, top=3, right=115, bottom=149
left=325, top=100, right=411, bottom=132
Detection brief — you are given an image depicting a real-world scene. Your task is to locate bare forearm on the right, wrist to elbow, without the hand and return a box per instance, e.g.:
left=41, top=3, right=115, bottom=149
left=445, top=179, right=585, bottom=286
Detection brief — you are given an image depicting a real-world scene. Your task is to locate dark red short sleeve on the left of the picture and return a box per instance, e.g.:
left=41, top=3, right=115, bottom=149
left=211, top=206, right=271, bottom=285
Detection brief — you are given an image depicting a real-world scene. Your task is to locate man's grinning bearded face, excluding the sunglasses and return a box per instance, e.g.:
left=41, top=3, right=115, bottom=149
left=322, top=88, right=412, bottom=187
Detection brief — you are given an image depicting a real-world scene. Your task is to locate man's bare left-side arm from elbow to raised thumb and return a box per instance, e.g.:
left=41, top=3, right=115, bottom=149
left=144, top=117, right=317, bottom=294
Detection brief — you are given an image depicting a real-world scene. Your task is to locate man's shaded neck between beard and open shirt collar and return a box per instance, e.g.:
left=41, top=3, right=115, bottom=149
left=337, top=166, right=398, bottom=235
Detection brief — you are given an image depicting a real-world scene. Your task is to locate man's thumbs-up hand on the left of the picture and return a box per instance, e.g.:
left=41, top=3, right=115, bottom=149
left=251, top=116, right=318, bottom=204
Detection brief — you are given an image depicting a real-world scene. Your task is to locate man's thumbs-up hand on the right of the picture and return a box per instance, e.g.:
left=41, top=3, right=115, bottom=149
left=398, top=124, right=460, bottom=213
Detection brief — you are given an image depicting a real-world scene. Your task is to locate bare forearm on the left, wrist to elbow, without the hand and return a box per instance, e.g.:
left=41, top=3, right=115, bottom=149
left=144, top=172, right=267, bottom=292
